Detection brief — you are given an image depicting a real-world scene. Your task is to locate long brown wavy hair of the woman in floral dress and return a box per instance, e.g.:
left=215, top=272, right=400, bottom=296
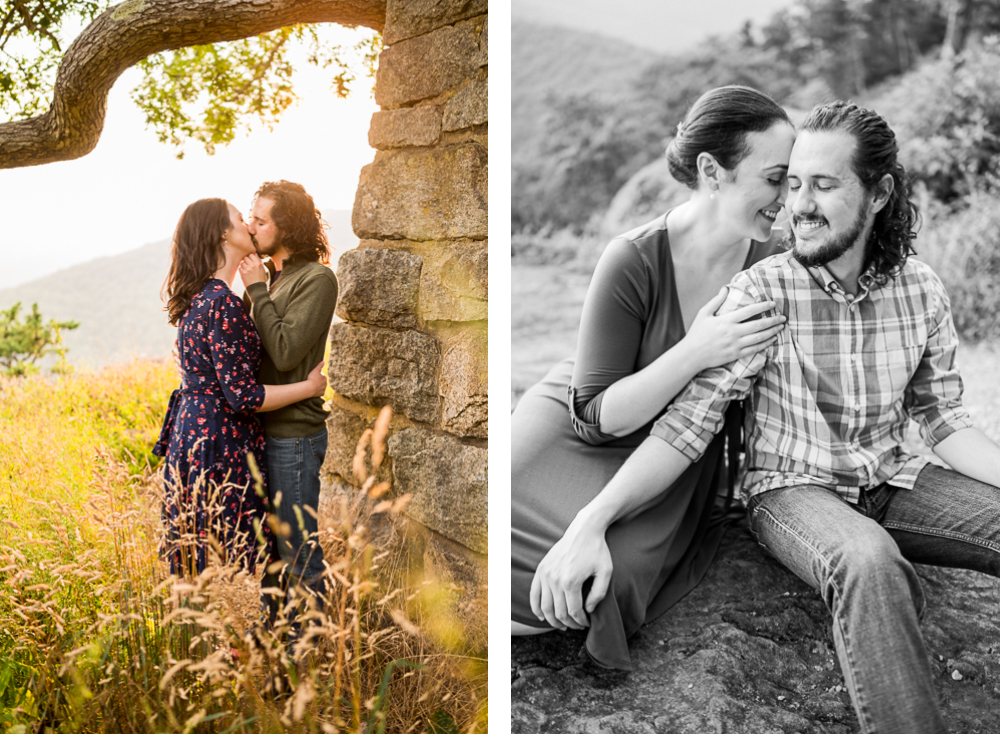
left=160, top=199, right=233, bottom=326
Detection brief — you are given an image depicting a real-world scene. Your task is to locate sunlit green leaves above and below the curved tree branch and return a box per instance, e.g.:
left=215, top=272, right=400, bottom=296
left=0, top=0, right=381, bottom=157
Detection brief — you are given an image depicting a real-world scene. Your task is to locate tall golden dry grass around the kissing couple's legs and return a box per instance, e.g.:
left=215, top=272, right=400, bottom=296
left=0, top=362, right=486, bottom=734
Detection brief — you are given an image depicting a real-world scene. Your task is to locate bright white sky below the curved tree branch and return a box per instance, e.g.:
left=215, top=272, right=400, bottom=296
left=0, top=26, right=378, bottom=288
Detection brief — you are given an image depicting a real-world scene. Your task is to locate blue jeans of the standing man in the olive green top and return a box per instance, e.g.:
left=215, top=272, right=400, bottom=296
left=261, top=429, right=327, bottom=639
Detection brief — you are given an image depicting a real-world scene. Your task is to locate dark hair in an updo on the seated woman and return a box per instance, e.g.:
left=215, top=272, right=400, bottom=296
left=667, top=84, right=792, bottom=189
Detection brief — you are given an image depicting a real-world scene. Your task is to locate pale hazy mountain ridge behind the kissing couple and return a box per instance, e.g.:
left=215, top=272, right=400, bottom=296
left=0, top=210, right=358, bottom=368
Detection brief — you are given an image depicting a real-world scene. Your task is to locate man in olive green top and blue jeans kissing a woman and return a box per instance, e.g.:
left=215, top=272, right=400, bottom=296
left=240, top=181, right=337, bottom=639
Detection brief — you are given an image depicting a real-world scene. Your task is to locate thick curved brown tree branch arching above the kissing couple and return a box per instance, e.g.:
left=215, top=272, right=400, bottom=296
left=0, top=0, right=385, bottom=169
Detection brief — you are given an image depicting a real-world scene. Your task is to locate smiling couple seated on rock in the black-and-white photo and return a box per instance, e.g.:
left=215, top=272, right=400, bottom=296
left=511, top=87, right=1000, bottom=734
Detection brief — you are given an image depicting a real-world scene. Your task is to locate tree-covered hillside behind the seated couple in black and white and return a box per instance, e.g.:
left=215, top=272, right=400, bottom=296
left=511, top=0, right=1000, bottom=339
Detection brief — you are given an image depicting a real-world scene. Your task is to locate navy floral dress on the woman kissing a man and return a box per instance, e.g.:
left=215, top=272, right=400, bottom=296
left=153, top=278, right=271, bottom=574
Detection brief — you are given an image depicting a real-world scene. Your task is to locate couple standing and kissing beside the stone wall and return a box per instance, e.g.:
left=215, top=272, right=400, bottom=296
left=154, top=181, right=337, bottom=656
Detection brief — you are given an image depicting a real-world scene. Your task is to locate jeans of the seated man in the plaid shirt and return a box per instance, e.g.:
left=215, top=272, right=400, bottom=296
left=748, top=466, right=1000, bottom=734
